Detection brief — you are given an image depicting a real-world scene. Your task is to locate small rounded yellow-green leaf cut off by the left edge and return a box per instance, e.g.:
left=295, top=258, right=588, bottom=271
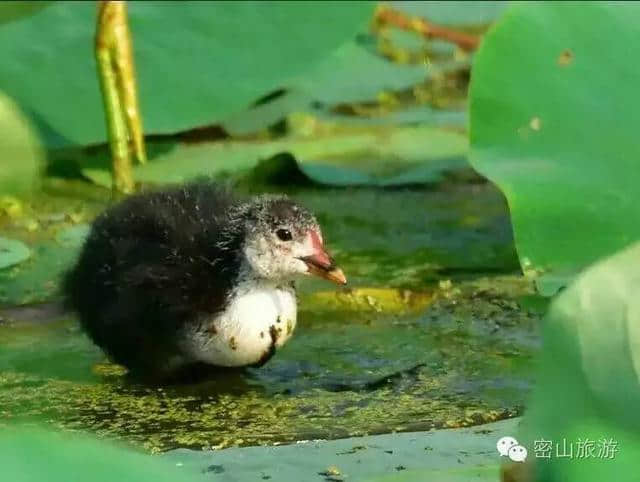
left=0, top=92, right=44, bottom=195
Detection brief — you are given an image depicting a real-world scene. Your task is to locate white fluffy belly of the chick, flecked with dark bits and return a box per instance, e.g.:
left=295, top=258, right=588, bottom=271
left=186, top=287, right=297, bottom=367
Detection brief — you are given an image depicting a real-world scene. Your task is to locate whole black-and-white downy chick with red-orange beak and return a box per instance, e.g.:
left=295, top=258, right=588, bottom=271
left=63, top=181, right=346, bottom=378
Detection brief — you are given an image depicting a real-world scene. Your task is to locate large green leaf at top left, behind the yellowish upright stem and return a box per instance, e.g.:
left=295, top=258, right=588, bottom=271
left=0, top=1, right=375, bottom=144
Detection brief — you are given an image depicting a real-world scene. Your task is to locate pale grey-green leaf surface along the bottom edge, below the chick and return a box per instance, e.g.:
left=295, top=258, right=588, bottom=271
left=162, top=419, right=519, bottom=482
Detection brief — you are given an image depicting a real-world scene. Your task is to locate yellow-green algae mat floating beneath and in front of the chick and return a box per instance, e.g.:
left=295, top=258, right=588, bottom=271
left=0, top=278, right=537, bottom=452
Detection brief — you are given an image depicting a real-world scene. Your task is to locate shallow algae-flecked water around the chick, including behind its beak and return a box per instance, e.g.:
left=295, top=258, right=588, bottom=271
left=0, top=181, right=539, bottom=451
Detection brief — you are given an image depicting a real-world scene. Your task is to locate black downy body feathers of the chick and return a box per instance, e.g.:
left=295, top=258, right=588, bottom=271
left=63, top=182, right=243, bottom=373
